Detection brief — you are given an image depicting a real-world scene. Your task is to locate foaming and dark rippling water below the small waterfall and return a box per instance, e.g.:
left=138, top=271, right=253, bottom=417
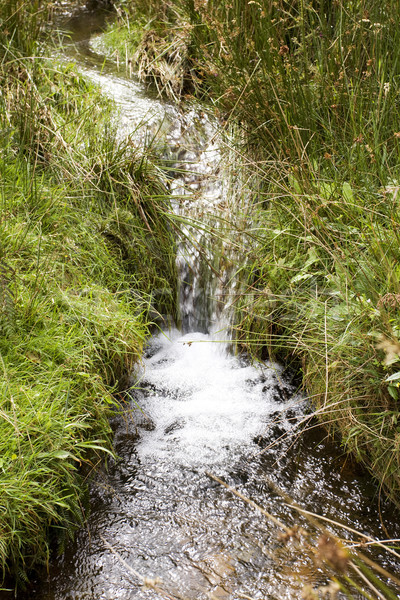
left=25, top=332, right=400, bottom=600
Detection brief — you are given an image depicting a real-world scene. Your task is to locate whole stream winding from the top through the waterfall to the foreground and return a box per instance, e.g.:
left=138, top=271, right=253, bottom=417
left=20, top=5, right=399, bottom=600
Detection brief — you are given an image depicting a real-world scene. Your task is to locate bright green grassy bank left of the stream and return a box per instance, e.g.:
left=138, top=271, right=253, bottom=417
left=0, top=0, right=176, bottom=582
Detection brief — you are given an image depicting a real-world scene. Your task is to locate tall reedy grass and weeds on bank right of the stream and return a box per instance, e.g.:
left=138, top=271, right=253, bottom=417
left=109, top=0, right=400, bottom=510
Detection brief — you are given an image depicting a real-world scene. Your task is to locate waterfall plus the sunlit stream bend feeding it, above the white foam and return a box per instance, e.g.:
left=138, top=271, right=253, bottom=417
left=75, top=56, right=245, bottom=340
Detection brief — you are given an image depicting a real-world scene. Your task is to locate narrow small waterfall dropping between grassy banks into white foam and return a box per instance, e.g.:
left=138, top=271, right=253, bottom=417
left=166, top=109, right=247, bottom=342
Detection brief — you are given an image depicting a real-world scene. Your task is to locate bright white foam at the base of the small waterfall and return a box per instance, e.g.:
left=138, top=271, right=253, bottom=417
left=138, top=332, right=287, bottom=467
